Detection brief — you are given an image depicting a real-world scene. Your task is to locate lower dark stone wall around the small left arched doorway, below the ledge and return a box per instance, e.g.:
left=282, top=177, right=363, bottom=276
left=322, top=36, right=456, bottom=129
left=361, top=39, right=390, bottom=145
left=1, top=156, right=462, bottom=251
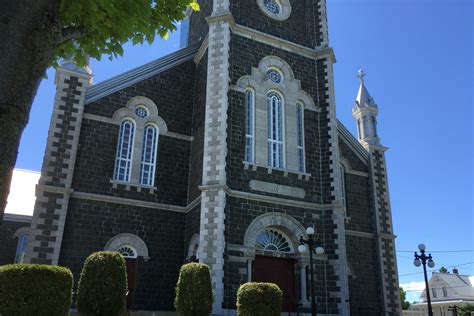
left=59, top=198, right=186, bottom=310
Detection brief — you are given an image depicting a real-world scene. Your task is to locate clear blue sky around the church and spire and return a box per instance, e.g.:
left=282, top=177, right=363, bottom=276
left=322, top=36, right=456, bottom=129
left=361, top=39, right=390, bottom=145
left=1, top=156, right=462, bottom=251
left=12, top=0, right=474, bottom=300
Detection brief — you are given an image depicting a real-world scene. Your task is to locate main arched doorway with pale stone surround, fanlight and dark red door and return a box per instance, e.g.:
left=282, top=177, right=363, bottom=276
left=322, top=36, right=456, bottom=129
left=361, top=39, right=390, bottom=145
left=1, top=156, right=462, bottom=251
left=244, top=213, right=309, bottom=312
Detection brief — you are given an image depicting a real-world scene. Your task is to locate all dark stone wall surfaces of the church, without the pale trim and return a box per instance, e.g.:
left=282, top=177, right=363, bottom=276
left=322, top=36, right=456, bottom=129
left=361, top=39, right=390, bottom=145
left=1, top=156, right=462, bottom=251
left=22, top=0, right=396, bottom=315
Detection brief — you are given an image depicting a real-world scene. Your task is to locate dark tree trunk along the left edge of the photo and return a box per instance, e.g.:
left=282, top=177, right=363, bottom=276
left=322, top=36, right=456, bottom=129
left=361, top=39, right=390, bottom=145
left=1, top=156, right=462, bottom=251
left=0, top=0, right=60, bottom=219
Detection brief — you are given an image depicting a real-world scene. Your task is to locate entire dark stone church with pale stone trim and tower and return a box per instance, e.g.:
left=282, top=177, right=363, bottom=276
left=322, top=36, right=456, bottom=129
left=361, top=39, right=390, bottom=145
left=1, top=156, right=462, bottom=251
left=25, top=0, right=401, bottom=315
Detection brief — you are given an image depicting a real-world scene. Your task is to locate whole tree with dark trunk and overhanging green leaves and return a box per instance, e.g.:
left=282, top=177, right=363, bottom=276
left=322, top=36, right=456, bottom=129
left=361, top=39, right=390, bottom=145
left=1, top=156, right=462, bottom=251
left=0, top=0, right=199, bottom=220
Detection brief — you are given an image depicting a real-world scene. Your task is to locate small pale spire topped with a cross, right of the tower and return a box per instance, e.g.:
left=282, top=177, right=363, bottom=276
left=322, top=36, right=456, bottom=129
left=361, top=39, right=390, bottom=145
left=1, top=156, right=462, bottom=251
left=352, top=69, right=380, bottom=147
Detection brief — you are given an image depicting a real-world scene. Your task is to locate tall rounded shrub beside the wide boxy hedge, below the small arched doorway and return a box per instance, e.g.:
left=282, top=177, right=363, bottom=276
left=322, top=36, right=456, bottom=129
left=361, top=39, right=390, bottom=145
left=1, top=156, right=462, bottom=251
left=77, top=251, right=127, bottom=316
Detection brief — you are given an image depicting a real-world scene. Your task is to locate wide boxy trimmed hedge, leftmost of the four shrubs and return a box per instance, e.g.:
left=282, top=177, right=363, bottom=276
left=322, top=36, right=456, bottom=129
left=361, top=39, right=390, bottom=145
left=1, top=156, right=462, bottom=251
left=0, top=264, right=73, bottom=316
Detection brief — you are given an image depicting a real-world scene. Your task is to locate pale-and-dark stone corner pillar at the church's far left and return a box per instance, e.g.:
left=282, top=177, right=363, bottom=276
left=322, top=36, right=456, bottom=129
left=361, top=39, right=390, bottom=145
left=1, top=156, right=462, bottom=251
left=25, top=68, right=91, bottom=264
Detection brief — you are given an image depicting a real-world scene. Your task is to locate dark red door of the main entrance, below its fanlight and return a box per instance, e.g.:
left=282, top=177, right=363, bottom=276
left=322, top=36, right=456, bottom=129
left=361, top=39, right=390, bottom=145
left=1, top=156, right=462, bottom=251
left=252, top=256, right=298, bottom=312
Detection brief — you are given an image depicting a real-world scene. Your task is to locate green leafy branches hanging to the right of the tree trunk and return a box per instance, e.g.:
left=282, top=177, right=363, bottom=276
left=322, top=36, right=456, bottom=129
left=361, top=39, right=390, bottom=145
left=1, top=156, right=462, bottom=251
left=53, top=0, right=199, bottom=65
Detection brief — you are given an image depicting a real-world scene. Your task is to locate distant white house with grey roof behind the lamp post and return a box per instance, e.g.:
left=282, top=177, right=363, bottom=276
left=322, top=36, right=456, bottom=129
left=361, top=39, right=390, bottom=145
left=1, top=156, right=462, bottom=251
left=403, top=269, right=474, bottom=316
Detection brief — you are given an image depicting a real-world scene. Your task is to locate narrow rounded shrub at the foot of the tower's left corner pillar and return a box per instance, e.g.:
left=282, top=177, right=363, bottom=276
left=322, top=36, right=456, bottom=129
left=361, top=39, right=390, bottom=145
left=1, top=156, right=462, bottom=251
left=174, top=263, right=214, bottom=316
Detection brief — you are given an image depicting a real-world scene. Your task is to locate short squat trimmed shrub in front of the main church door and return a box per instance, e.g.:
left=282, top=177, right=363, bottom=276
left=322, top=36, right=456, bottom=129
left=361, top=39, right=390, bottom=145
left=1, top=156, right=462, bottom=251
left=237, top=282, right=283, bottom=316
